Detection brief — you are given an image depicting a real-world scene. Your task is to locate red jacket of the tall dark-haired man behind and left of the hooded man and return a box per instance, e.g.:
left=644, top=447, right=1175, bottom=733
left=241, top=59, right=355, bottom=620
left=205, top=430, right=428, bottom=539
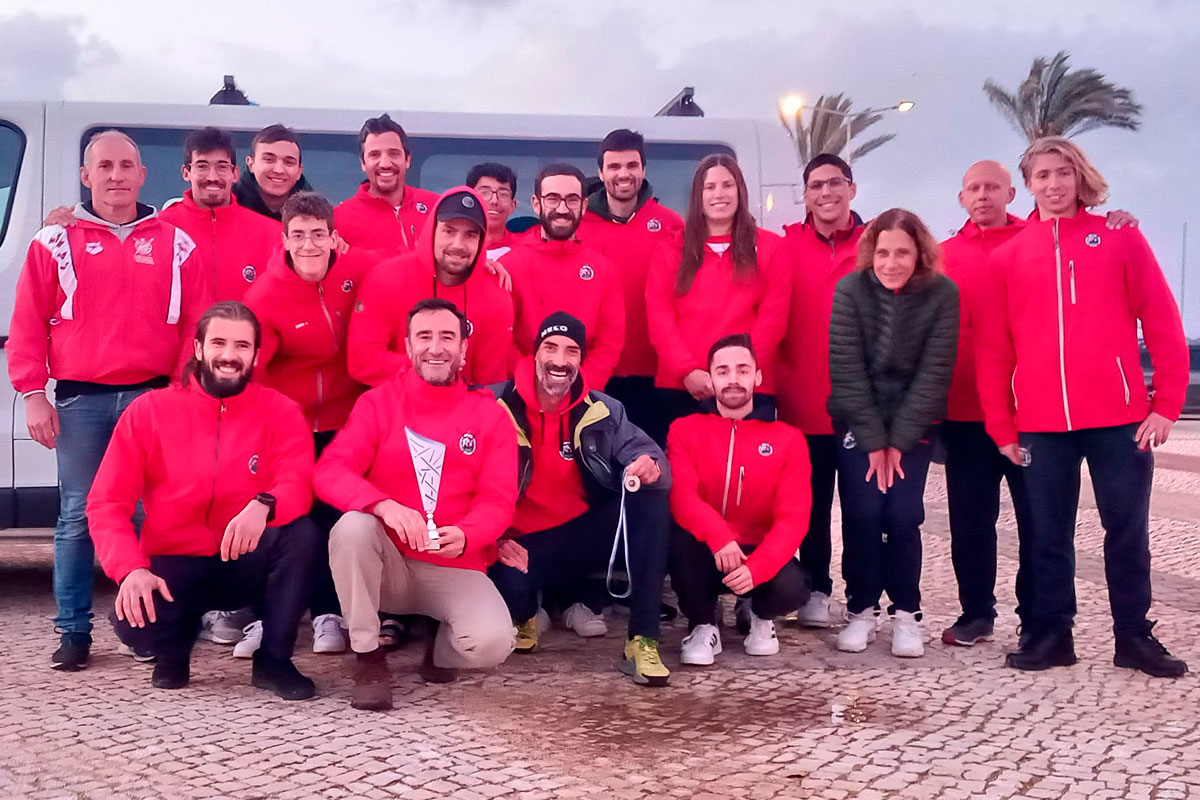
left=334, top=181, right=438, bottom=255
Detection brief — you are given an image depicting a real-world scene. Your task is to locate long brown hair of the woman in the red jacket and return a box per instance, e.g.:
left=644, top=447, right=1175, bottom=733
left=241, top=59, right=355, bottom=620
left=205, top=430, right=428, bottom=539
left=676, top=152, right=758, bottom=297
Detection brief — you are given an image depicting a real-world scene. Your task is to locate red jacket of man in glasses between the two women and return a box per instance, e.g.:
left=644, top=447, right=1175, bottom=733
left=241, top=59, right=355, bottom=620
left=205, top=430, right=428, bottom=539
left=778, top=212, right=864, bottom=435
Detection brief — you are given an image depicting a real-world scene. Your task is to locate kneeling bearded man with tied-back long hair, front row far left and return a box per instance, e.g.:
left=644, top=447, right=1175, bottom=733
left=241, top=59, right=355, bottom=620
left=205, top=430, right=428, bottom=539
left=88, top=301, right=320, bottom=700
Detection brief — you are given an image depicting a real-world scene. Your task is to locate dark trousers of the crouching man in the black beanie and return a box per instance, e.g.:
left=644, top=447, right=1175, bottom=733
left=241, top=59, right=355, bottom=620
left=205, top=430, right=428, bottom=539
left=487, top=488, right=671, bottom=638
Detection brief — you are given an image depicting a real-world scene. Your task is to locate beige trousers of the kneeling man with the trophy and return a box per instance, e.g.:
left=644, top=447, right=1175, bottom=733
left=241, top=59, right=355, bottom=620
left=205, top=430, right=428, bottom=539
left=329, top=511, right=516, bottom=668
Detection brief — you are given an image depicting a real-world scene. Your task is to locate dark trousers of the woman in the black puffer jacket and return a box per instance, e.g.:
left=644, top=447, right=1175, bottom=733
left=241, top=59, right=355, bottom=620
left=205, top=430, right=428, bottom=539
left=836, top=439, right=930, bottom=614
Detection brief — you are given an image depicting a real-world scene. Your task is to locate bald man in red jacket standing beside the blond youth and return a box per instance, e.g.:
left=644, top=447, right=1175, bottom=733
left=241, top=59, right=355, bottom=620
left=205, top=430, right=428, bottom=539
left=942, top=161, right=1138, bottom=646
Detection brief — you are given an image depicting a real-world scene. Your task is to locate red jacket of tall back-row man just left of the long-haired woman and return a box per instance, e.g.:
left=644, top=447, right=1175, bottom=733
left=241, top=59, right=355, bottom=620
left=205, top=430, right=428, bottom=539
left=578, top=196, right=683, bottom=378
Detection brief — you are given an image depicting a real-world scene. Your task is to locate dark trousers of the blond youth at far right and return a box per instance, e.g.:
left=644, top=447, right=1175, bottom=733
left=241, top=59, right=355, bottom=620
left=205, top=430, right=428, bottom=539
left=1020, top=425, right=1154, bottom=636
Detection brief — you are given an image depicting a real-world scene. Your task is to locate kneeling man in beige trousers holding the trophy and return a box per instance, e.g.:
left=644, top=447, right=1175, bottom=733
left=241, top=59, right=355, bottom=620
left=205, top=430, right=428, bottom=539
left=313, top=297, right=517, bottom=710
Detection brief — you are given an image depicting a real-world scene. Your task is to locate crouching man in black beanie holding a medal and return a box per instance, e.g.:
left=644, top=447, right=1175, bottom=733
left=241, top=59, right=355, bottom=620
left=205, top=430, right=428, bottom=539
left=487, top=311, right=671, bottom=686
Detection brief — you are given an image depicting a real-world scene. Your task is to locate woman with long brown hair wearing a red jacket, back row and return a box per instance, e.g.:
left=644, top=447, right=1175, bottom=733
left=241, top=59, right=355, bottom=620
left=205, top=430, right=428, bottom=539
left=646, top=154, right=792, bottom=441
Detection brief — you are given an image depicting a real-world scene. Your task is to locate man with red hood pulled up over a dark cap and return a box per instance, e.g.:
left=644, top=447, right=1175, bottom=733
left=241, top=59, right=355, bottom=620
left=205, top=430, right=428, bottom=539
left=347, top=186, right=512, bottom=386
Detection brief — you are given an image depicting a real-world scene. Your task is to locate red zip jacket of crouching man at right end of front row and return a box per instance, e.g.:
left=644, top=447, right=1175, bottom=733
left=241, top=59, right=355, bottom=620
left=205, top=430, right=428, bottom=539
left=667, top=413, right=812, bottom=585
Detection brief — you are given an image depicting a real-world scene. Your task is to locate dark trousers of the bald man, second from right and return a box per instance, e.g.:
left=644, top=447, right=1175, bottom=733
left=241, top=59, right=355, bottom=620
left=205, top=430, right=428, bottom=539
left=942, top=422, right=1033, bottom=627
